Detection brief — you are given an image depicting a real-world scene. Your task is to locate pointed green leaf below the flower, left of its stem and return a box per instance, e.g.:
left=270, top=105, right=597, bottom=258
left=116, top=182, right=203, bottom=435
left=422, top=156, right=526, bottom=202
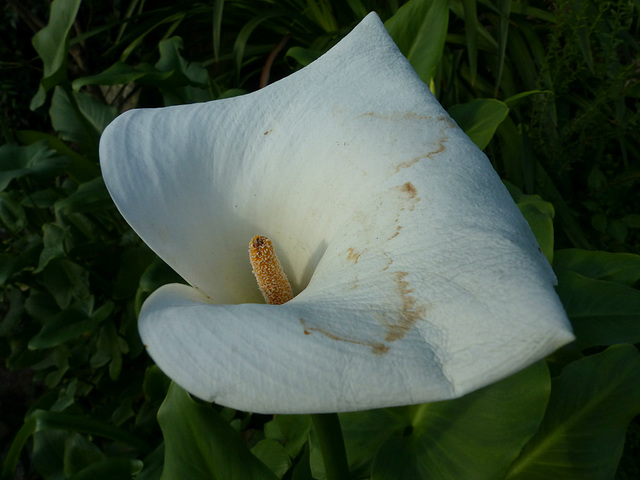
left=158, top=384, right=277, bottom=480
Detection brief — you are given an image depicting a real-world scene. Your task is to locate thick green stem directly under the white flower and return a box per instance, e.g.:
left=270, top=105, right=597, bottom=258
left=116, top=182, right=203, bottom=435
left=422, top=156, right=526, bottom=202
left=311, top=413, right=349, bottom=480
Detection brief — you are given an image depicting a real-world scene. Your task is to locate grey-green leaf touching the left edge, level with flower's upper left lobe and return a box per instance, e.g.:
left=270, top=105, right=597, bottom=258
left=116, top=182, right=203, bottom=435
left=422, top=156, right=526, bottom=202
left=0, top=141, right=69, bottom=192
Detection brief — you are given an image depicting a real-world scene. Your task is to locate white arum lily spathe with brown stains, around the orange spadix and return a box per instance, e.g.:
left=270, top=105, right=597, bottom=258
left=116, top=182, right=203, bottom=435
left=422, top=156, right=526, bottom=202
left=100, top=14, right=573, bottom=413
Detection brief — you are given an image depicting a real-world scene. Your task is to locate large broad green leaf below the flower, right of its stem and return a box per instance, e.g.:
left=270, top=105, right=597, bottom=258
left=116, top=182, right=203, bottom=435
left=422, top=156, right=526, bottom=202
left=340, top=362, right=550, bottom=480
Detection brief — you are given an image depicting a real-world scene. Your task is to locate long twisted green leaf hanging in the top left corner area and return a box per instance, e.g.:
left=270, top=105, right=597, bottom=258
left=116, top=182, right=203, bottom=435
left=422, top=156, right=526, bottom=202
left=30, top=0, right=82, bottom=110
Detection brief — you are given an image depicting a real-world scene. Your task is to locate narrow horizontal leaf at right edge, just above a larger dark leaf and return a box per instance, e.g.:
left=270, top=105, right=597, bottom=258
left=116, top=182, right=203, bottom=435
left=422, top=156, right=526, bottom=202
left=553, top=248, right=640, bottom=286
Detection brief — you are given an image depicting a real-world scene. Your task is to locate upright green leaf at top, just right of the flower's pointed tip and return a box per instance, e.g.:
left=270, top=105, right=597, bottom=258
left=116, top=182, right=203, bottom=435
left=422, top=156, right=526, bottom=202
left=384, top=0, right=449, bottom=85
